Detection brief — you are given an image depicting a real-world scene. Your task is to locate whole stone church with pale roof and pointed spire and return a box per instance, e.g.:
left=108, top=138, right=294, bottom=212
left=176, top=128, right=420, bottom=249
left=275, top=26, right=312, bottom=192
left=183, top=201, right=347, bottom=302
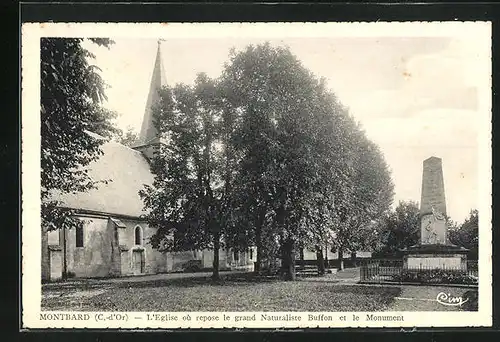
left=41, top=44, right=256, bottom=281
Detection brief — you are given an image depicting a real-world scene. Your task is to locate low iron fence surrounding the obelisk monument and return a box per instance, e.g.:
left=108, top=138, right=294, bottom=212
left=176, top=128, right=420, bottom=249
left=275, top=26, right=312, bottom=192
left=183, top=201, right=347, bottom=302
left=360, top=259, right=478, bottom=285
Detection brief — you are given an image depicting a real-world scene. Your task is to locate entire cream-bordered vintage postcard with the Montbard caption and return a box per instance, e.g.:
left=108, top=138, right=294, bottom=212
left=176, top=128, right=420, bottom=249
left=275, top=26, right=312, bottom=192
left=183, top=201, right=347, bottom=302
left=22, top=22, right=491, bottom=328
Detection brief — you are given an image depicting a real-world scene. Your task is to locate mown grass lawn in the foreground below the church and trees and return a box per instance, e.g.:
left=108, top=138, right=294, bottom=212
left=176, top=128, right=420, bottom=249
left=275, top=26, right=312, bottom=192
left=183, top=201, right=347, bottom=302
left=42, top=274, right=401, bottom=312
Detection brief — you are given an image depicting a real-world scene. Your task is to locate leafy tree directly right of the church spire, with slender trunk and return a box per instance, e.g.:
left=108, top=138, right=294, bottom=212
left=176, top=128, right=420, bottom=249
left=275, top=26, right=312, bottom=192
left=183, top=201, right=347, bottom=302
left=141, top=74, right=233, bottom=279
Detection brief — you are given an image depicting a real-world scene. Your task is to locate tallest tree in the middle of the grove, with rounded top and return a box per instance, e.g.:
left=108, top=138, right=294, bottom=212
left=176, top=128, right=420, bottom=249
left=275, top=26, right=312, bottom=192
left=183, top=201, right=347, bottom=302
left=222, top=44, right=338, bottom=279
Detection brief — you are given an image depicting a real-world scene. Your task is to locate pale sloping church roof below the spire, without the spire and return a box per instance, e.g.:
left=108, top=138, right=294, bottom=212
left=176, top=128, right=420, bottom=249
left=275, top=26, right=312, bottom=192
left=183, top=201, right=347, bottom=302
left=53, top=141, right=153, bottom=217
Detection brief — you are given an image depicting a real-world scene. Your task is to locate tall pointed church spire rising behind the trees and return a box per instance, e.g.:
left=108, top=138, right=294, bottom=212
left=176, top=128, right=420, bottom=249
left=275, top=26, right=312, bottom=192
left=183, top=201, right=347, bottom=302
left=139, top=39, right=167, bottom=145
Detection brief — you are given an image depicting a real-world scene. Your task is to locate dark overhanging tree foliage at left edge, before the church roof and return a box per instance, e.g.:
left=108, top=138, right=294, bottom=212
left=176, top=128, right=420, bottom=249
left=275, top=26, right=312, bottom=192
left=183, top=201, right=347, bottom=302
left=40, top=38, right=116, bottom=229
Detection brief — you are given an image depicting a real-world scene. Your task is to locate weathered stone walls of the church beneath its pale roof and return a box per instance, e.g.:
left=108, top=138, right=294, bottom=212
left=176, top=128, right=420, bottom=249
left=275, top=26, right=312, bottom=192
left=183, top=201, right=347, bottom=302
left=42, top=216, right=257, bottom=280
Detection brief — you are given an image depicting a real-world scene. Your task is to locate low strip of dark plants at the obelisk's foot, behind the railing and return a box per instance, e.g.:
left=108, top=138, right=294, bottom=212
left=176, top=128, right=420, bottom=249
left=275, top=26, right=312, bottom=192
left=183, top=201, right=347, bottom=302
left=392, top=269, right=477, bottom=285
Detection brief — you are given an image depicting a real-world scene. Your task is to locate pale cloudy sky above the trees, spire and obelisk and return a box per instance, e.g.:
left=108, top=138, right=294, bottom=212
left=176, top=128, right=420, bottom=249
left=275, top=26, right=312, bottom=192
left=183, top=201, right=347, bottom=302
left=82, top=31, right=489, bottom=222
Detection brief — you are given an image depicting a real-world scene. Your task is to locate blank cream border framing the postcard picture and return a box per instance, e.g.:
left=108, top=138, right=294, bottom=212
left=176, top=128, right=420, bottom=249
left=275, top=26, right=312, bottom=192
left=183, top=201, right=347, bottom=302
left=22, top=22, right=492, bottom=329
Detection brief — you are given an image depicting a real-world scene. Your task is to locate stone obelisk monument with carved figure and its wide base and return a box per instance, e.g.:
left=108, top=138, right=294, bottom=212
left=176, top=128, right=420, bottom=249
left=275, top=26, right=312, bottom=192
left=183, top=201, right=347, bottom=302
left=403, top=157, right=467, bottom=269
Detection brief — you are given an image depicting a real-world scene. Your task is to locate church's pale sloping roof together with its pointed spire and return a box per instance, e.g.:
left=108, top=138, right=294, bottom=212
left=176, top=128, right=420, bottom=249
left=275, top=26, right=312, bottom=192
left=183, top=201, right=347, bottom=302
left=53, top=41, right=167, bottom=217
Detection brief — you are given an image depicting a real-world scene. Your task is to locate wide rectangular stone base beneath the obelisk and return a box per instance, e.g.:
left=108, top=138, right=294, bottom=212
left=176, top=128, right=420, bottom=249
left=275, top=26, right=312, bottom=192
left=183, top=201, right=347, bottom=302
left=402, top=244, right=468, bottom=271
